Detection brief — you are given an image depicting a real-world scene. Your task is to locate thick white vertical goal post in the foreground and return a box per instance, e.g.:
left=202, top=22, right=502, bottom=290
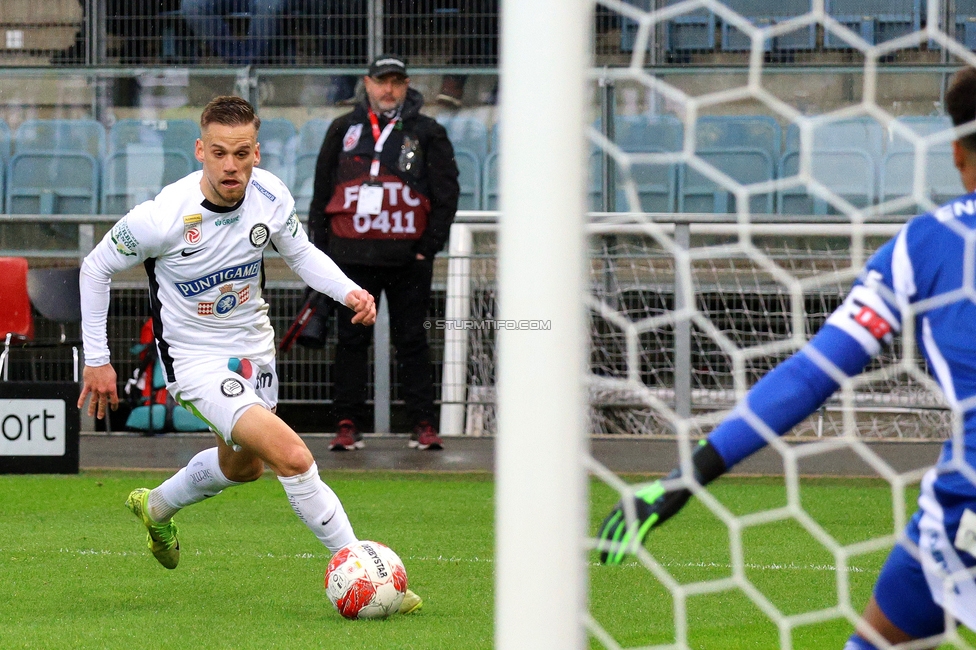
left=495, top=0, right=594, bottom=650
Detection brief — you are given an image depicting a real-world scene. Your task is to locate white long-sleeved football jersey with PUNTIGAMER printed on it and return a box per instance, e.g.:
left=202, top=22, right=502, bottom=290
left=81, top=168, right=359, bottom=381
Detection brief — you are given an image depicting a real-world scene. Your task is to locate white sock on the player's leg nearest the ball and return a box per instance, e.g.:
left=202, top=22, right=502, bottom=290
left=278, top=463, right=356, bottom=553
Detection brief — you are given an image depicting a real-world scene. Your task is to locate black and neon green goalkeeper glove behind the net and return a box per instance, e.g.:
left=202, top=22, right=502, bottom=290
left=597, top=470, right=691, bottom=564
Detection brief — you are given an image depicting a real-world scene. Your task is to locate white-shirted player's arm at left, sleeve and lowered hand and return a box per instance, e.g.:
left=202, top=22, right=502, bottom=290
left=78, top=202, right=160, bottom=419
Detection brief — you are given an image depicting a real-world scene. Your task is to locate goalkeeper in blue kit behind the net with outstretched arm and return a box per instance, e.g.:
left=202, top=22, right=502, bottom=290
left=598, top=68, right=976, bottom=650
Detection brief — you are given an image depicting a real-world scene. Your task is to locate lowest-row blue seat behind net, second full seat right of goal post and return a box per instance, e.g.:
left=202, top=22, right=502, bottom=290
left=678, top=148, right=775, bottom=214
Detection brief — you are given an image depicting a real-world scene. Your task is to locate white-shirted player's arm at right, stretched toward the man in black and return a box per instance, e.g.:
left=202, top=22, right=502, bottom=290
left=271, top=197, right=376, bottom=325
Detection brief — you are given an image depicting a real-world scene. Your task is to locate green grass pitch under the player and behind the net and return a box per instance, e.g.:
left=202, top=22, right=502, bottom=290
left=0, top=472, right=973, bottom=650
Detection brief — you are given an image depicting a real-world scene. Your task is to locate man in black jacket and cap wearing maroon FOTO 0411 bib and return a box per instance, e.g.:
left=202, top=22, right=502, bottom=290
left=308, top=54, right=460, bottom=451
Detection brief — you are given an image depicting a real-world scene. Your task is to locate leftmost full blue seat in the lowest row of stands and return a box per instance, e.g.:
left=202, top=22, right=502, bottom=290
left=6, top=151, right=98, bottom=214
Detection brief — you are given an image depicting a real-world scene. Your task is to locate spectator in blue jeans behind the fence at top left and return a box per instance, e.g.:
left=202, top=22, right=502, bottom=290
left=181, top=0, right=287, bottom=65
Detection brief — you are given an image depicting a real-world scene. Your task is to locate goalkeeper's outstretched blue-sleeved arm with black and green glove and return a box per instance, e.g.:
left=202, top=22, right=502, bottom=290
left=597, top=227, right=915, bottom=564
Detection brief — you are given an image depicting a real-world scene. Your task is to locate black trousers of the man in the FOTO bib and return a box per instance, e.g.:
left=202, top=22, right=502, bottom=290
left=333, top=260, right=437, bottom=431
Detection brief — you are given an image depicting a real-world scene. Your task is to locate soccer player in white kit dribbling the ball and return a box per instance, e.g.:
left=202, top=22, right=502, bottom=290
left=78, top=97, right=421, bottom=612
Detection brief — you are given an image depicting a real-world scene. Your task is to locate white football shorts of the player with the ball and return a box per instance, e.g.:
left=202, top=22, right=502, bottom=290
left=166, top=358, right=278, bottom=449
